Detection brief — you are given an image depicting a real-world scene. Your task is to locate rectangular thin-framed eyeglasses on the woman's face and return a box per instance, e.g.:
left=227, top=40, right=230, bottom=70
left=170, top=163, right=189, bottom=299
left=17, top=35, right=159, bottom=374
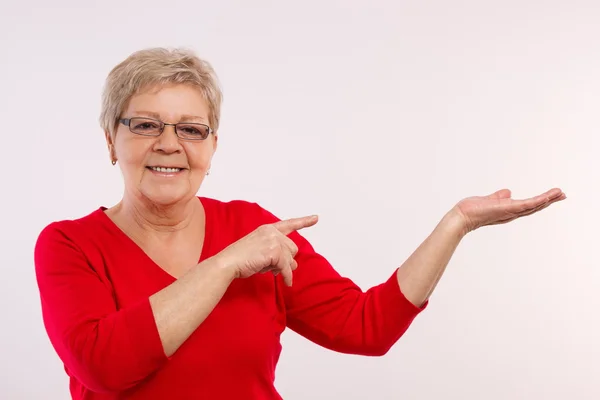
left=119, top=117, right=213, bottom=140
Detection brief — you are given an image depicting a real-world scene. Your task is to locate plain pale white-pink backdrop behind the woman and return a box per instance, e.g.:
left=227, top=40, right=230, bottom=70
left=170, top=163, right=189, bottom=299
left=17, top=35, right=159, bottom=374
left=0, top=0, right=600, bottom=400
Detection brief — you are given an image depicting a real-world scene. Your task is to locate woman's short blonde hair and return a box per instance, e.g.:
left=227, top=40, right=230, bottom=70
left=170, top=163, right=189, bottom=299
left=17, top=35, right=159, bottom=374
left=100, top=47, right=223, bottom=137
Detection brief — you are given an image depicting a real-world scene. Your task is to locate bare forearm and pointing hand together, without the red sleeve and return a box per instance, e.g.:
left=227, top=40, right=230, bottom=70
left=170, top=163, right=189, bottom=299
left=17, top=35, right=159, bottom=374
left=150, top=217, right=317, bottom=357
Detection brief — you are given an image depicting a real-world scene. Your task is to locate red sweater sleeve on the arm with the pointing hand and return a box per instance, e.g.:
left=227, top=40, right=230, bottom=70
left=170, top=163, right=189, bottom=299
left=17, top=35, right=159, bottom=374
left=34, top=222, right=167, bottom=393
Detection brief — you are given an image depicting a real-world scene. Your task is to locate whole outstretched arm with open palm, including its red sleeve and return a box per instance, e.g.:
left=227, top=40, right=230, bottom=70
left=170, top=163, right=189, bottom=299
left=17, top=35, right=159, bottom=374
left=264, top=189, right=566, bottom=356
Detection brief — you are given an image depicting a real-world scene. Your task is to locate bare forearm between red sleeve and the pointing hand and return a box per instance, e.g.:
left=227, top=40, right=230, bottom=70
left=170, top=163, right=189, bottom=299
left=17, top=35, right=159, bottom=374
left=150, top=258, right=234, bottom=357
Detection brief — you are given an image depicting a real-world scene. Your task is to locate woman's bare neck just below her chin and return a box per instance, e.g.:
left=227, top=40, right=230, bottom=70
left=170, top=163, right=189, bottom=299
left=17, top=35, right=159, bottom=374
left=113, top=194, right=203, bottom=233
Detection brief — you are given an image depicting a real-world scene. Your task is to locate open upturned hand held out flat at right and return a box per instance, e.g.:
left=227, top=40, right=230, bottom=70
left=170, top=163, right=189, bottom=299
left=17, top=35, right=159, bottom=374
left=455, top=188, right=567, bottom=232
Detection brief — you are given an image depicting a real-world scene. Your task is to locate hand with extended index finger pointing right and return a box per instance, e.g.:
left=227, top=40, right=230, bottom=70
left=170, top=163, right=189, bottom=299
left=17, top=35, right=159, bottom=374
left=217, top=216, right=318, bottom=286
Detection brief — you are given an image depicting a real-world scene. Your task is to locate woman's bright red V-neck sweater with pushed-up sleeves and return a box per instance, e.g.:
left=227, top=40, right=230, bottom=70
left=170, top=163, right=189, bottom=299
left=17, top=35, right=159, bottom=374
left=35, top=197, right=425, bottom=400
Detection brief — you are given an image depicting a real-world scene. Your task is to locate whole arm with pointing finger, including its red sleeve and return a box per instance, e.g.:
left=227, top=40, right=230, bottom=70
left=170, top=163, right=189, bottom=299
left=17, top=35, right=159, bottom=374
left=35, top=218, right=316, bottom=393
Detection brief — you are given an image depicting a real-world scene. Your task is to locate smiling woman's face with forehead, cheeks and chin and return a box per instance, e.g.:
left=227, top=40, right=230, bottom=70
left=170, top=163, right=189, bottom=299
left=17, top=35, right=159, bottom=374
left=107, top=85, right=217, bottom=206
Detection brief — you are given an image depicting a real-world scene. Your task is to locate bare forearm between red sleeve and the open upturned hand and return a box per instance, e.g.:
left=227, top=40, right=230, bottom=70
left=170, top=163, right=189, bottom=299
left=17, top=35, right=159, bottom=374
left=397, top=211, right=466, bottom=306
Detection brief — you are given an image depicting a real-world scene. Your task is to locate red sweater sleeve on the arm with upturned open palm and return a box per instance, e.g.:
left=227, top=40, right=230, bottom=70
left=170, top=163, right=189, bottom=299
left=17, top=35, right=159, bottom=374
left=253, top=205, right=427, bottom=356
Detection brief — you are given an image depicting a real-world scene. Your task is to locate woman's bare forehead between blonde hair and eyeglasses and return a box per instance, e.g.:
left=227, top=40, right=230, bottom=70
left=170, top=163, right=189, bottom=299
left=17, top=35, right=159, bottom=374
left=124, top=84, right=209, bottom=122
